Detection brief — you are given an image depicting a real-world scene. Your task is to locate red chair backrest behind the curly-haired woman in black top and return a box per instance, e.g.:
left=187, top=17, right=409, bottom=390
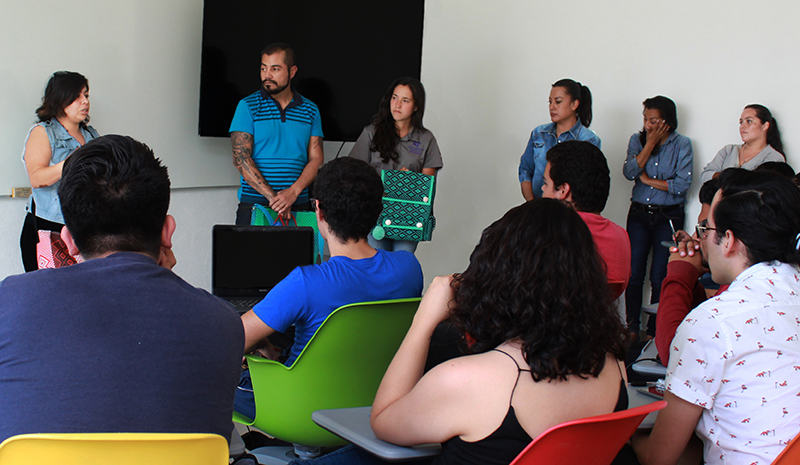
left=511, top=400, right=667, bottom=465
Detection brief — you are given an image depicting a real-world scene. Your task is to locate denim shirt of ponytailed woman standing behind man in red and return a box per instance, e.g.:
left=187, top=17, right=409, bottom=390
left=519, top=120, right=600, bottom=199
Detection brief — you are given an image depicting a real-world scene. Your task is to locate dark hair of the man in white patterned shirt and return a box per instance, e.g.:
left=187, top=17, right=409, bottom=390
left=713, top=168, right=800, bottom=265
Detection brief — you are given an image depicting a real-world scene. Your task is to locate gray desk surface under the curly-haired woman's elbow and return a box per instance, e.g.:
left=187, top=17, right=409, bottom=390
left=311, top=407, right=442, bottom=462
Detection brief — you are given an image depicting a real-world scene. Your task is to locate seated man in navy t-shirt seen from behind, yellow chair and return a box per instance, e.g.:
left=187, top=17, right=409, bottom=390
left=0, top=135, right=244, bottom=441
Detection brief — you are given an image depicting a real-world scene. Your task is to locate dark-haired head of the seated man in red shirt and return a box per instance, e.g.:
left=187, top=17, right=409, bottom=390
left=547, top=140, right=611, bottom=213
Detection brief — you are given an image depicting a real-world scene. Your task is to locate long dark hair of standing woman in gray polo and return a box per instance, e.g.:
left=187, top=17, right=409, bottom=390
left=369, top=77, right=425, bottom=163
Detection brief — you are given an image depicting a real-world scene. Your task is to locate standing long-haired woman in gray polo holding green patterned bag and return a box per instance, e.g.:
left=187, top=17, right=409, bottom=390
left=350, top=77, right=442, bottom=252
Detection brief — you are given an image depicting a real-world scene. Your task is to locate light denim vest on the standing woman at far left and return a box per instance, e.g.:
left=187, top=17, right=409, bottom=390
left=22, top=118, right=100, bottom=224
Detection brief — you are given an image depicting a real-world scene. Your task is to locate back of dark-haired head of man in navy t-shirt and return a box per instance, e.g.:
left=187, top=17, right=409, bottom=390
left=58, top=135, right=170, bottom=258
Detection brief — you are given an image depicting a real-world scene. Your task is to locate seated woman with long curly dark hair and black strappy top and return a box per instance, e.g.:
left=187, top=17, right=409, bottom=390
left=300, top=199, right=628, bottom=464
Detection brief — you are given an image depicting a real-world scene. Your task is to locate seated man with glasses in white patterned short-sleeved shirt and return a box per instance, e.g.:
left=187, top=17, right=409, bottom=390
left=632, top=169, right=800, bottom=465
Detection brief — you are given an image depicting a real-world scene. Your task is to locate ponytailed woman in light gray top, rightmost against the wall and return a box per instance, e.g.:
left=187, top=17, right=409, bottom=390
left=700, top=103, right=786, bottom=182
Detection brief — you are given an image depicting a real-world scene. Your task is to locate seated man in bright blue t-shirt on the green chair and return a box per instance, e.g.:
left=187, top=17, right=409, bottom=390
left=234, top=157, right=422, bottom=418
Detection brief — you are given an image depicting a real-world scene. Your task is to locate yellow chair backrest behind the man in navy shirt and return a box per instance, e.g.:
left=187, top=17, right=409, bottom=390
left=0, top=433, right=228, bottom=465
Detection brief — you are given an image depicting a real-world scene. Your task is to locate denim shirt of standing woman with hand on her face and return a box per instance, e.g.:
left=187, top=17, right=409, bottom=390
left=622, top=132, right=693, bottom=205
